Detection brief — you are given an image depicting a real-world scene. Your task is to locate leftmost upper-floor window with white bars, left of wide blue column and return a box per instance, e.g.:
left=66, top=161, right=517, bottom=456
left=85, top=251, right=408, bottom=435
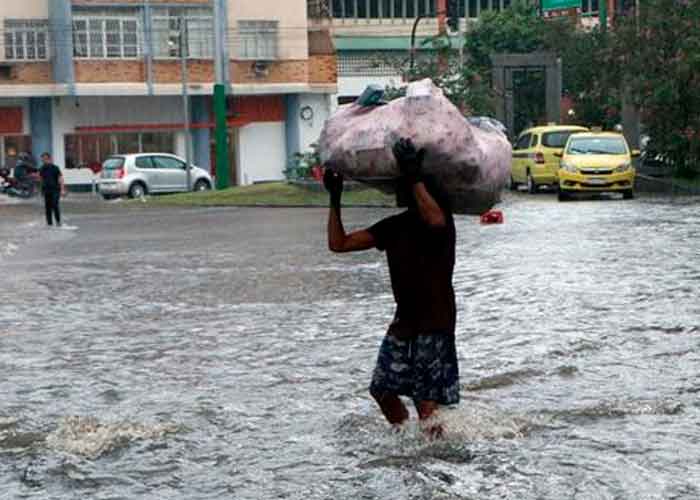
left=4, top=19, right=49, bottom=61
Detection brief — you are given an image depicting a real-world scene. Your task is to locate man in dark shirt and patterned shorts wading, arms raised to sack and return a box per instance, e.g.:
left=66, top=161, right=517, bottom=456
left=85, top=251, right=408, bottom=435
left=323, top=139, right=459, bottom=437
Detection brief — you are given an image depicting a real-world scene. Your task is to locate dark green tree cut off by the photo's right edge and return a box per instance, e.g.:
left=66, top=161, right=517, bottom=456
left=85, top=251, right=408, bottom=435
left=609, top=0, right=700, bottom=176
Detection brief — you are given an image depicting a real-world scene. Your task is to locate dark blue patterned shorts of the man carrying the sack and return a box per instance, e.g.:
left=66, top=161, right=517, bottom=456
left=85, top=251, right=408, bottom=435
left=370, top=334, right=459, bottom=405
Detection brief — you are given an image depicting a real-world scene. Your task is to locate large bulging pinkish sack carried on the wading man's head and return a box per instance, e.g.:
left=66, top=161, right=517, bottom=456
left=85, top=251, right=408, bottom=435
left=319, top=80, right=511, bottom=215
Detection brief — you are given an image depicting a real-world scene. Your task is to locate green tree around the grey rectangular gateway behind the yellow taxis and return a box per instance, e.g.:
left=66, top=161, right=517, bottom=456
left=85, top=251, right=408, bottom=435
left=392, top=0, right=621, bottom=129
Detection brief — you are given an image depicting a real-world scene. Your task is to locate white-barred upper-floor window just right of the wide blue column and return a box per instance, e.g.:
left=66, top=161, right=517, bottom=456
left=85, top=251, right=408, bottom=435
left=73, top=12, right=140, bottom=59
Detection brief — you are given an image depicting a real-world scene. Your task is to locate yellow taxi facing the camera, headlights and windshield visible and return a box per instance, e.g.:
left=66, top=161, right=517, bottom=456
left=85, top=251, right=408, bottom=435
left=558, top=132, right=639, bottom=201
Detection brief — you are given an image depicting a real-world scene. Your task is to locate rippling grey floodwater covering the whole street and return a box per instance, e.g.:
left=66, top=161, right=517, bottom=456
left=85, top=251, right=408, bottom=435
left=0, top=195, right=700, bottom=500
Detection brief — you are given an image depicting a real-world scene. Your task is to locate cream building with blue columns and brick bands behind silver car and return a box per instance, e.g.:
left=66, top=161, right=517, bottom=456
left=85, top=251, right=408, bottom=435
left=0, top=0, right=337, bottom=185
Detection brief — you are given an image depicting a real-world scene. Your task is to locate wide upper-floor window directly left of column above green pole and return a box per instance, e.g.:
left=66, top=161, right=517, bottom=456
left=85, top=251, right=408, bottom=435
left=153, top=8, right=214, bottom=59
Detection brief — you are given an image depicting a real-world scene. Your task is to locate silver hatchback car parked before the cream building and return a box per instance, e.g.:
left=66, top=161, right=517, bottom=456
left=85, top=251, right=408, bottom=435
left=98, top=153, right=213, bottom=198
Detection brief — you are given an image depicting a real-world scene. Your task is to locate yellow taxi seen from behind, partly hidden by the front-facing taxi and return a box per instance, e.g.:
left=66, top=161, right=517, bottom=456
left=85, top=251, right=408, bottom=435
left=510, top=124, right=588, bottom=193
